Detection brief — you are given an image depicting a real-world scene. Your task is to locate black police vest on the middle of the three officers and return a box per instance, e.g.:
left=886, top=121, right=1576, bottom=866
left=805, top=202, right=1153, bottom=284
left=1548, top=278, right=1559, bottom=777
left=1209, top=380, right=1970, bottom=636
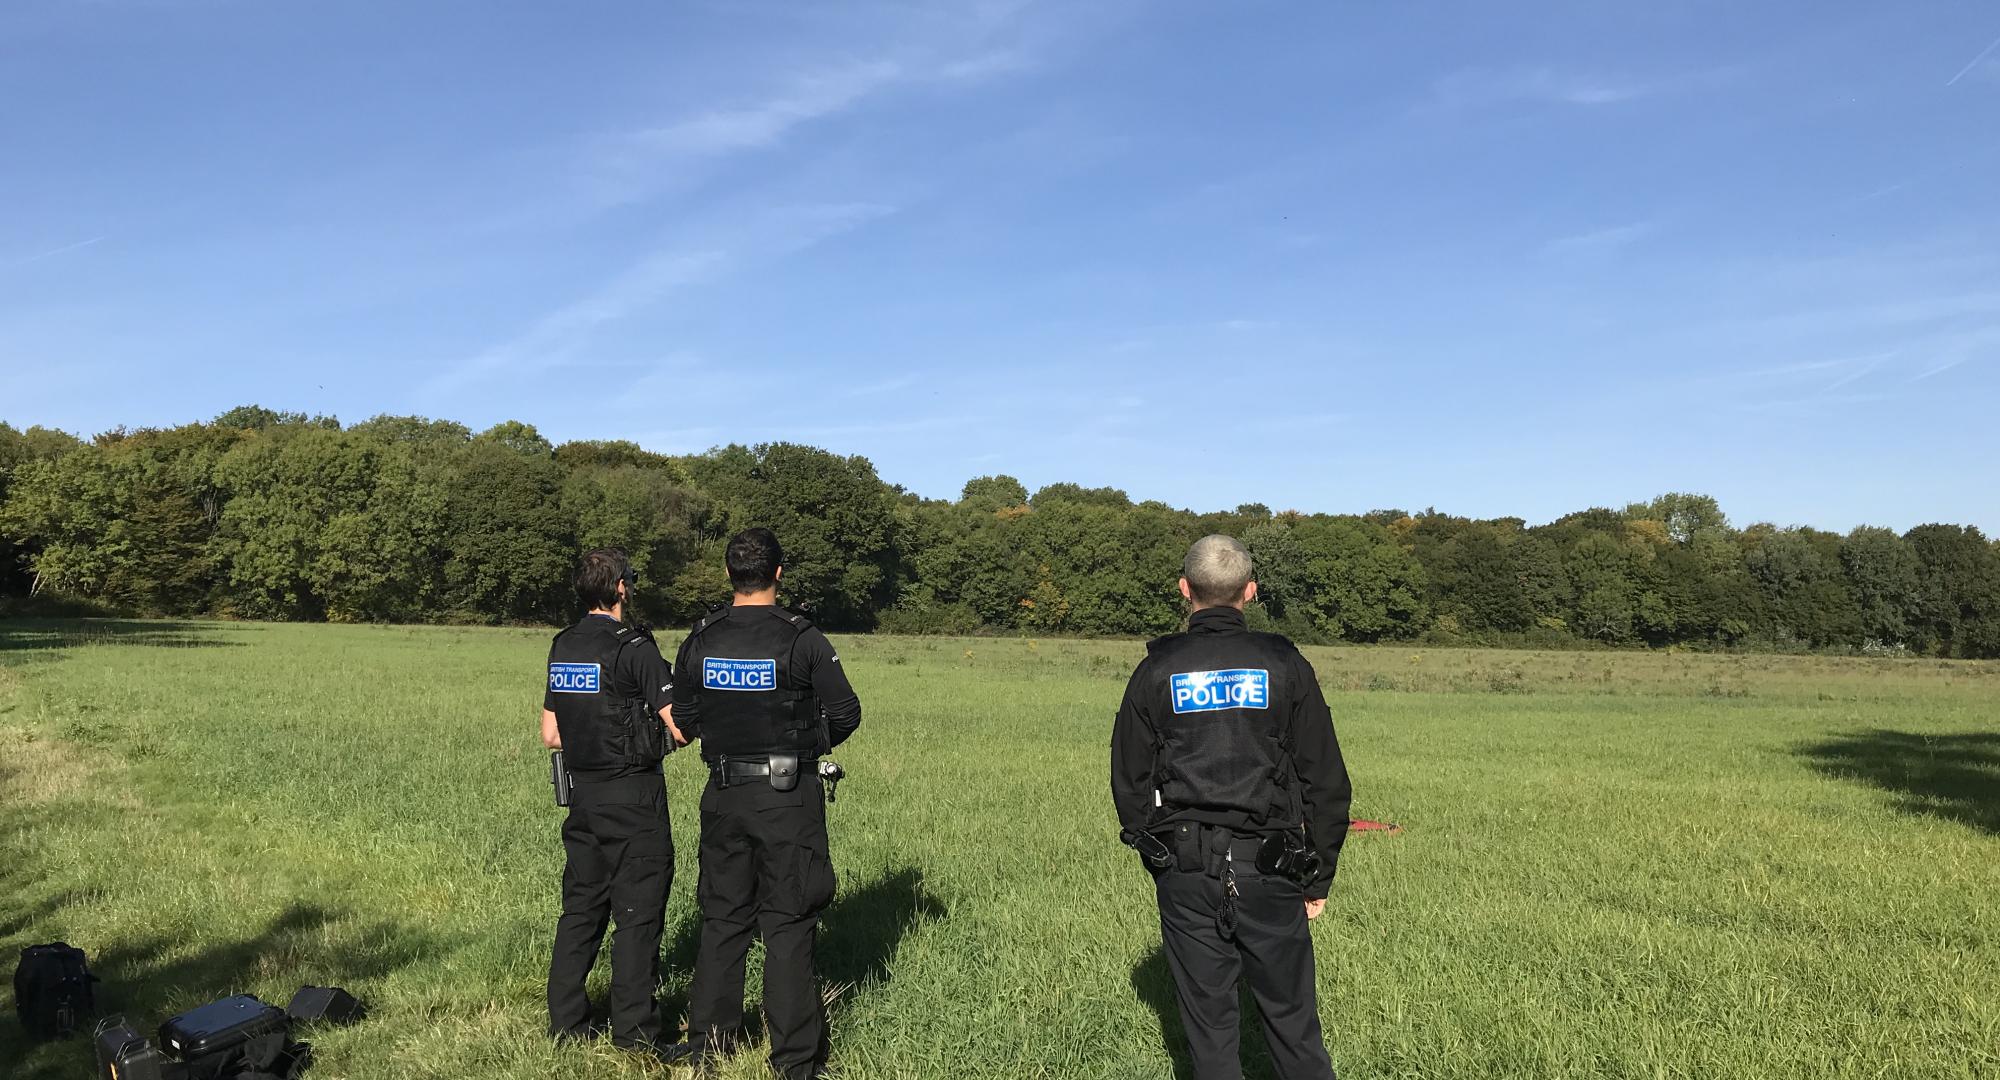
left=676, top=606, right=824, bottom=762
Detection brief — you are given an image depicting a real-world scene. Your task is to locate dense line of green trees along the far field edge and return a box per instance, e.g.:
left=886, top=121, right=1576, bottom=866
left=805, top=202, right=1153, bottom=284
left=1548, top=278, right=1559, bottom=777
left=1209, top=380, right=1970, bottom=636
left=0, top=406, right=2000, bottom=656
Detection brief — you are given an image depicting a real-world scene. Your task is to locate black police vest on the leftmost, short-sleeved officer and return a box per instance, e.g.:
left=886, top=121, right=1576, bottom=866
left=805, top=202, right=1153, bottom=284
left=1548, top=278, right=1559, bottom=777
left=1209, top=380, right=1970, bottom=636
left=548, top=616, right=666, bottom=772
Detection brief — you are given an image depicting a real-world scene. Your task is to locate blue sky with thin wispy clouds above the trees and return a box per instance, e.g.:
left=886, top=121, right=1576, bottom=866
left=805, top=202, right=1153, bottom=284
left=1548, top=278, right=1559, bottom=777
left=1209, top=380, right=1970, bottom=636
left=0, top=0, right=2000, bottom=532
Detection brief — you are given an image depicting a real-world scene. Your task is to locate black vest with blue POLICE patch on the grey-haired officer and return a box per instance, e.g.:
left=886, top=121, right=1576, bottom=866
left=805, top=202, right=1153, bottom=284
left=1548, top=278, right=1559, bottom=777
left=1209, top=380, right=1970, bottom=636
left=1148, top=632, right=1302, bottom=824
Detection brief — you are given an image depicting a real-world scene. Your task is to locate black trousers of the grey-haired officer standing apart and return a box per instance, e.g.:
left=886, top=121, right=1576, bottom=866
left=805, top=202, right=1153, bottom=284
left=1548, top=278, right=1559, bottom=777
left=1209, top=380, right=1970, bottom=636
left=1154, top=862, right=1334, bottom=1080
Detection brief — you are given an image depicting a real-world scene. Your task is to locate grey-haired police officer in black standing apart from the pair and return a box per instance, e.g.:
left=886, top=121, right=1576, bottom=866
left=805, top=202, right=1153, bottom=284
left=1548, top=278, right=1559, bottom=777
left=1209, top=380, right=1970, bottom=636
left=1112, top=536, right=1352, bottom=1080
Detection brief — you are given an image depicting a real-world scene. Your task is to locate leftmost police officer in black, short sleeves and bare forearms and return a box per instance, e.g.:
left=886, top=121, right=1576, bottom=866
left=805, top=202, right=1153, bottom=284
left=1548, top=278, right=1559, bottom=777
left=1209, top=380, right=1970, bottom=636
left=542, top=548, right=686, bottom=1050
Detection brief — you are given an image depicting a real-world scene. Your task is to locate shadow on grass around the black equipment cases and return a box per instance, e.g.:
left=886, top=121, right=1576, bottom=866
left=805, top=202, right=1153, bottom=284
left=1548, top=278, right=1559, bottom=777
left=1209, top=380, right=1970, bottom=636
left=0, top=904, right=446, bottom=1080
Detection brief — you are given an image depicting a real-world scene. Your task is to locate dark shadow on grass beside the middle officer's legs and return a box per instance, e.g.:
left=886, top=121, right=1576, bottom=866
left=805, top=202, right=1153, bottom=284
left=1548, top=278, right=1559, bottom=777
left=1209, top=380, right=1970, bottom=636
left=660, top=866, right=950, bottom=1038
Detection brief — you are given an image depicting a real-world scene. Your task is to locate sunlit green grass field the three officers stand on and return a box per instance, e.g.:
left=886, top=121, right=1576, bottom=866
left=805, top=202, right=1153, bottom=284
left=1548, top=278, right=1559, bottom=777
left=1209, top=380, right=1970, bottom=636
left=0, top=622, right=2000, bottom=1080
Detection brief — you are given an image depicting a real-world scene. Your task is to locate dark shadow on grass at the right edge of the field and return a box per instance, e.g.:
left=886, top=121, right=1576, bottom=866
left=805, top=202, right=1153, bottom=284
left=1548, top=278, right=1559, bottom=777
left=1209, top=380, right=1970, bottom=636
left=1798, top=728, right=2000, bottom=834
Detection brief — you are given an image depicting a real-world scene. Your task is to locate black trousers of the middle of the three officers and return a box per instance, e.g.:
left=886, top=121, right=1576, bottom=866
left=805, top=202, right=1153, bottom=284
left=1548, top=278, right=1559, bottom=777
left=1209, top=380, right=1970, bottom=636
left=688, top=776, right=834, bottom=1080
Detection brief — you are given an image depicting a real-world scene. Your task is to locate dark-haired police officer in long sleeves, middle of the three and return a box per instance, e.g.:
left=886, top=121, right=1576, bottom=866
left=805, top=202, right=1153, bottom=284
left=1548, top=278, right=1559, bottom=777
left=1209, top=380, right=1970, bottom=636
left=666, top=528, right=862, bottom=1080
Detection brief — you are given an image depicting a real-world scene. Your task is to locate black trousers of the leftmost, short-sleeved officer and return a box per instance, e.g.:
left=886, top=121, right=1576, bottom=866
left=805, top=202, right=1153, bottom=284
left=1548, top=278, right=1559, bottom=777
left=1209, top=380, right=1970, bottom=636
left=548, top=772, right=674, bottom=1046
